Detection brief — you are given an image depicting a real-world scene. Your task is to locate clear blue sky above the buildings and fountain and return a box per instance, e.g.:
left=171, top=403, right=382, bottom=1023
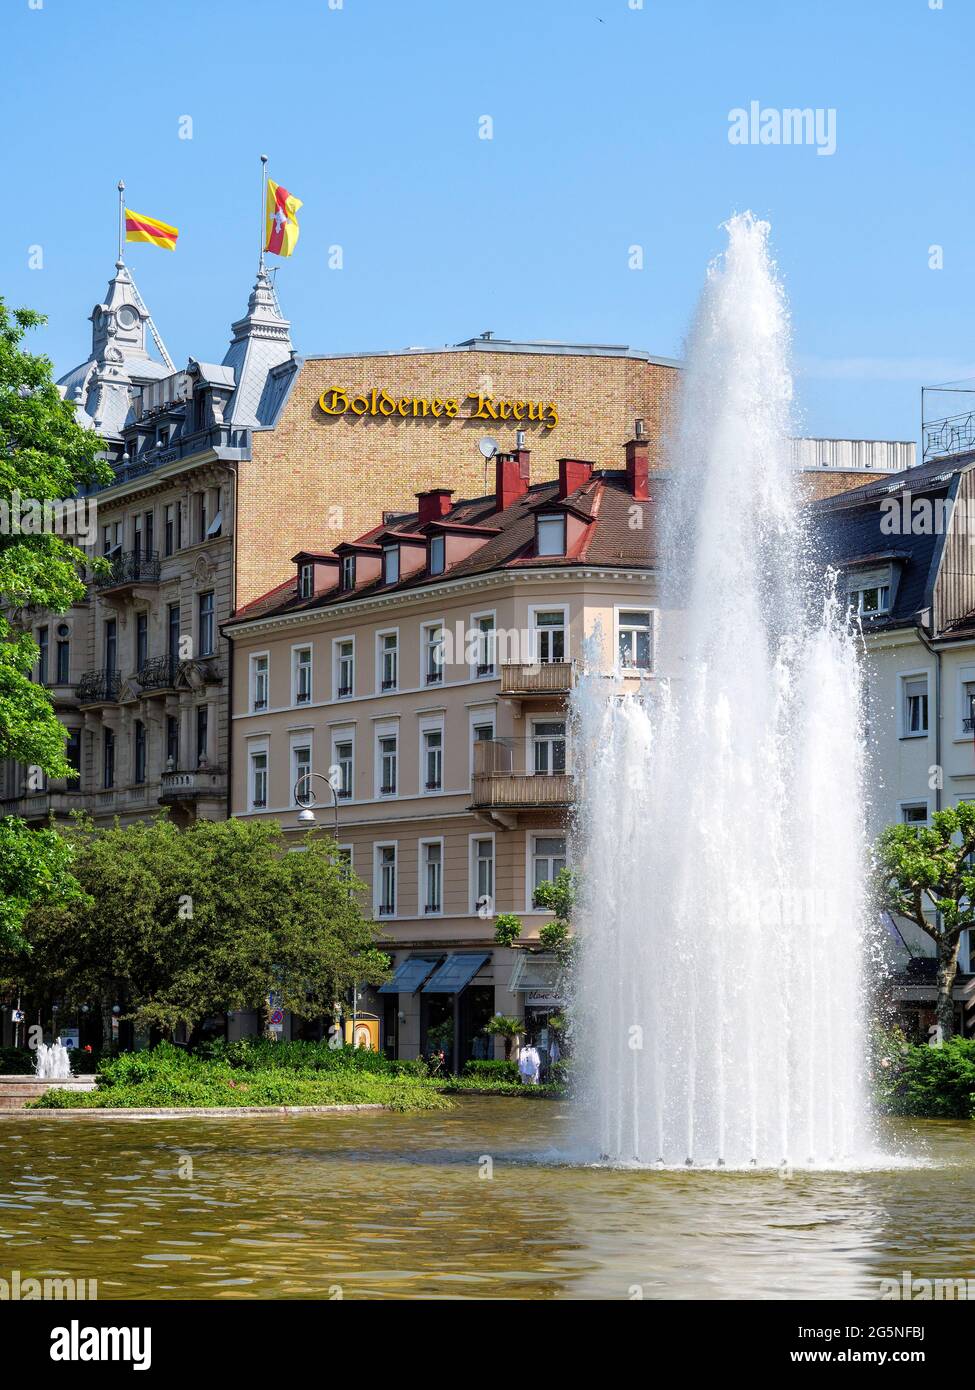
left=0, top=0, right=975, bottom=438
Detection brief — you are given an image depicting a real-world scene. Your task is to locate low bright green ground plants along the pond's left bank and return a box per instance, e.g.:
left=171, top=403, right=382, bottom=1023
left=36, top=1043, right=449, bottom=1111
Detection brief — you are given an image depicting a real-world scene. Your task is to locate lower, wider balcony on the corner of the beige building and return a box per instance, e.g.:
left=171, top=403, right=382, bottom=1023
left=472, top=738, right=576, bottom=828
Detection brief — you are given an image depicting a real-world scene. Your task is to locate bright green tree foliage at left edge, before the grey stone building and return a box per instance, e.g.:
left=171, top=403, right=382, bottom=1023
left=0, top=299, right=113, bottom=947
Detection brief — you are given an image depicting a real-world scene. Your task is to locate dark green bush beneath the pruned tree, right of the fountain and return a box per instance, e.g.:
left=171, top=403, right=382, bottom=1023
left=875, top=1038, right=975, bottom=1120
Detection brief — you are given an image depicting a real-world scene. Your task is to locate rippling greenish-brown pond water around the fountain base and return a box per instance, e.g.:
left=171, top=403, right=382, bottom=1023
left=0, top=1098, right=975, bottom=1298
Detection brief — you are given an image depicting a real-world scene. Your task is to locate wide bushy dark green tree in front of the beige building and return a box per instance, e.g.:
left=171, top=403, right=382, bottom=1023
left=13, top=816, right=388, bottom=1036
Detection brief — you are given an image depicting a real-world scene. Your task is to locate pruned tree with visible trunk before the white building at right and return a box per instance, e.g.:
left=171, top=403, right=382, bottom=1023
left=875, top=802, right=975, bottom=1043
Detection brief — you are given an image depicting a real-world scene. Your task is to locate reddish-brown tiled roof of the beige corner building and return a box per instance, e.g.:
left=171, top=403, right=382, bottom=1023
left=232, top=470, right=653, bottom=621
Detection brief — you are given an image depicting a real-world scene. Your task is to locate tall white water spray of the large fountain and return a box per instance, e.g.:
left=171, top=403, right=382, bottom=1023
left=573, top=214, right=865, bottom=1166
